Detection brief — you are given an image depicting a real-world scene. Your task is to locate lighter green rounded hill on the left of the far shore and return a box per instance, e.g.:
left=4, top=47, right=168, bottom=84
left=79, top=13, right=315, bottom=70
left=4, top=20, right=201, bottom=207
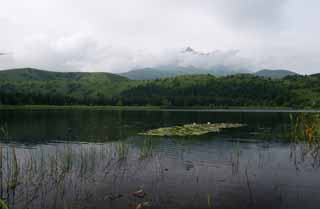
left=0, top=68, right=134, bottom=104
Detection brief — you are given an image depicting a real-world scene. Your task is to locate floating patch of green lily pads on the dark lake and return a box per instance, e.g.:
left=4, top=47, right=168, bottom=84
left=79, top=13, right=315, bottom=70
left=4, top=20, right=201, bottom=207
left=140, top=123, right=245, bottom=136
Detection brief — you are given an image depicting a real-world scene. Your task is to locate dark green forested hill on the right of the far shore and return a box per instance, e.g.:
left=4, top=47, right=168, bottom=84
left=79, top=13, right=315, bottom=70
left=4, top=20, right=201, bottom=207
left=121, top=74, right=320, bottom=108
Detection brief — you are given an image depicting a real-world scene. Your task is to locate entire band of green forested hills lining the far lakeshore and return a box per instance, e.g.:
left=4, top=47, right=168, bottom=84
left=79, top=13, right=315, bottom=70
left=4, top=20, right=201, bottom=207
left=0, top=68, right=320, bottom=109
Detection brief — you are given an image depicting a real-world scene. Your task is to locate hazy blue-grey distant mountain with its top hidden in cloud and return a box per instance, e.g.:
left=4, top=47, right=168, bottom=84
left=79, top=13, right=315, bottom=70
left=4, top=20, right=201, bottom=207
left=120, top=66, right=249, bottom=80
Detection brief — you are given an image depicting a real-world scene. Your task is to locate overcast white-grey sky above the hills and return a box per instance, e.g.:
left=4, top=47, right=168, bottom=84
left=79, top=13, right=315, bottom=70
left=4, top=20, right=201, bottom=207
left=0, top=0, right=320, bottom=73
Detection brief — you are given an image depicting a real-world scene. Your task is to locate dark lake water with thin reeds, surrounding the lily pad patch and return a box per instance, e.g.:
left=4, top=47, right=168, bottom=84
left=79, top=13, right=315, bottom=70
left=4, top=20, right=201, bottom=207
left=0, top=110, right=320, bottom=209
